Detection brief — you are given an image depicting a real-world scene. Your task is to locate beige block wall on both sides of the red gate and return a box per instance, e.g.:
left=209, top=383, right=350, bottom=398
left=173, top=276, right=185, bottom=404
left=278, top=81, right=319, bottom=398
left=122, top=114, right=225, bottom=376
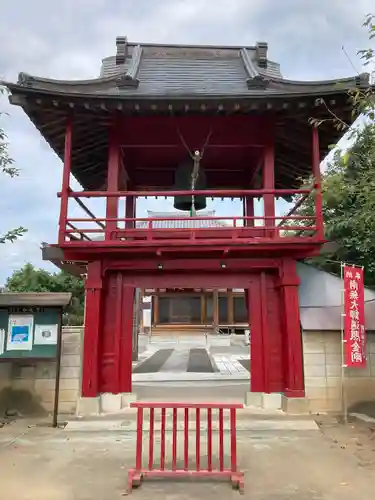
left=0, top=327, right=375, bottom=416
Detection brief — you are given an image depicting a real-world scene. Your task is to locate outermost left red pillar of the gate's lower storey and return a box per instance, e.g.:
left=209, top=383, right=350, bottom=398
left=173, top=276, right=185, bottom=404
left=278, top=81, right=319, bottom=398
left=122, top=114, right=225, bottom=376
left=82, top=261, right=103, bottom=398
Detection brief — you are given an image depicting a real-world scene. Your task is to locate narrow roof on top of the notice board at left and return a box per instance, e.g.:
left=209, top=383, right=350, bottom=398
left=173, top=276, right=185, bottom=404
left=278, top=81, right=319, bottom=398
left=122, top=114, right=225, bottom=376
left=0, top=292, right=72, bottom=307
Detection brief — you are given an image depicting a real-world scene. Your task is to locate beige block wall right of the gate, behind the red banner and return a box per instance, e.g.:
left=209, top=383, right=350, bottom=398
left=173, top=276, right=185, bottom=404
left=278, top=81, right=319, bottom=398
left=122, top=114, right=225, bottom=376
left=303, top=332, right=375, bottom=413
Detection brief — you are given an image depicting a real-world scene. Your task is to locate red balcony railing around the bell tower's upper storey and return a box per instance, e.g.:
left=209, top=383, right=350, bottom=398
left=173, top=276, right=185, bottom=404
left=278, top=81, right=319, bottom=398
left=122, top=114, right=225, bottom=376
left=59, top=189, right=322, bottom=246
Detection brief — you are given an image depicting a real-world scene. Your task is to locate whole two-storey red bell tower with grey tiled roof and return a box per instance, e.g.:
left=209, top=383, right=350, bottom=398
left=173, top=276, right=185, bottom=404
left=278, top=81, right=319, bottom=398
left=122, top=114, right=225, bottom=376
left=7, top=37, right=368, bottom=406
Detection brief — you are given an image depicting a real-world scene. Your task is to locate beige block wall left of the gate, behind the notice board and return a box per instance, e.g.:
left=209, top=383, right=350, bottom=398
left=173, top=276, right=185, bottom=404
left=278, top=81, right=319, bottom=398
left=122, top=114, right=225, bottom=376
left=0, top=327, right=83, bottom=414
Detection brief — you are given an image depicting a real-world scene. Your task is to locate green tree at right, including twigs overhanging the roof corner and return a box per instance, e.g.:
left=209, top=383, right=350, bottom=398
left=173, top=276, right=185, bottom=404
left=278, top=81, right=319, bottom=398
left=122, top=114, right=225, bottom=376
left=298, top=14, right=375, bottom=285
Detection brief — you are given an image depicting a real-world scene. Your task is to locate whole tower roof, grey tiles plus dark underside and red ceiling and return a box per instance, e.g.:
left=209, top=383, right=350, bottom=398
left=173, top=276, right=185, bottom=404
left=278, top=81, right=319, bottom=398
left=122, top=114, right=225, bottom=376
left=5, top=37, right=369, bottom=191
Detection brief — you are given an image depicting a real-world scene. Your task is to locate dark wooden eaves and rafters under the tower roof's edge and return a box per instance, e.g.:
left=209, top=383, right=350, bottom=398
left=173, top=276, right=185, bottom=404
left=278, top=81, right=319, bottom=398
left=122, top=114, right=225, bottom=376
left=2, top=73, right=368, bottom=190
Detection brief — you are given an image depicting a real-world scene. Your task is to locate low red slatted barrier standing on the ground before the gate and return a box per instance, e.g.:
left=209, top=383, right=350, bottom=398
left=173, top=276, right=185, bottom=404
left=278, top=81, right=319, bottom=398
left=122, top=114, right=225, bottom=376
left=128, top=402, right=244, bottom=493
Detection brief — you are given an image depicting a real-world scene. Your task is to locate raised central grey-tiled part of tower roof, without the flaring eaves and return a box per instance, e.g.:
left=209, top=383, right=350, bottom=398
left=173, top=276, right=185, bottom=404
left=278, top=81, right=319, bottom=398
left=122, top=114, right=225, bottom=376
left=100, top=43, right=281, bottom=96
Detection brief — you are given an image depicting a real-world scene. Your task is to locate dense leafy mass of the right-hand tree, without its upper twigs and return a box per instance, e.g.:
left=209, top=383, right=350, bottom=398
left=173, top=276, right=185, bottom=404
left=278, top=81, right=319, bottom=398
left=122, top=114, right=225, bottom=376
left=298, top=124, right=375, bottom=285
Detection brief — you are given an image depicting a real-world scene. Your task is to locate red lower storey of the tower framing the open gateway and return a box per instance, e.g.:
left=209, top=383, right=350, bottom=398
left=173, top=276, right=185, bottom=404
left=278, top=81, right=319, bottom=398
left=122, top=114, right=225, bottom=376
left=83, top=259, right=304, bottom=397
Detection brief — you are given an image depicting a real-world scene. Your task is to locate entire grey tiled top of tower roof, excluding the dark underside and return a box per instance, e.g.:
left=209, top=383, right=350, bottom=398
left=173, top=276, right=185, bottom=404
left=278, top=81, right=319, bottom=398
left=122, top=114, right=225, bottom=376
left=7, top=37, right=369, bottom=99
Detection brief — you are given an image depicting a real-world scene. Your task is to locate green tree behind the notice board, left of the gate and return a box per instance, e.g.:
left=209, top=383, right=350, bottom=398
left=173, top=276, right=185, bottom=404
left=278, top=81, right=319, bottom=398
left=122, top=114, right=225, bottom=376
left=6, top=264, right=85, bottom=325
